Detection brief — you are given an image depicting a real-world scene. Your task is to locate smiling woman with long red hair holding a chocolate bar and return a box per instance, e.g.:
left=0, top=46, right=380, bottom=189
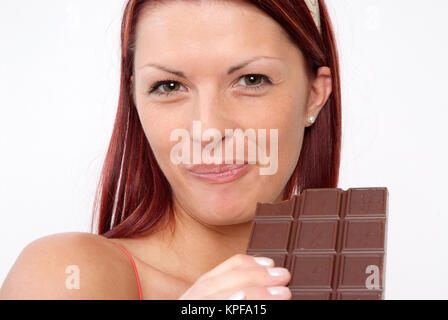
left=0, top=0, right=341, bottom=299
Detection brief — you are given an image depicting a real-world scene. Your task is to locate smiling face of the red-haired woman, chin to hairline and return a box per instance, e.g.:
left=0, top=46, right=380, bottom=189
left=132, top=1, right=325, bottom=225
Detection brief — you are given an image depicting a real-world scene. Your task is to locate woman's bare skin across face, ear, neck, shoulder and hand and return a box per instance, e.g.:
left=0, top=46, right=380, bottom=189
left=0, top=1, right=331, bottom=299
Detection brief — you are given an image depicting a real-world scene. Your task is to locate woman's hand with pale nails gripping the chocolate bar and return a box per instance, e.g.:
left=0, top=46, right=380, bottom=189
left=179, top=254, right=291, bottom=300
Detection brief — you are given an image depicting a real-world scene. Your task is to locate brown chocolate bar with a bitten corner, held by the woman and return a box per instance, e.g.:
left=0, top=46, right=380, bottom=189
left=247, top=188, right=389, bottom=300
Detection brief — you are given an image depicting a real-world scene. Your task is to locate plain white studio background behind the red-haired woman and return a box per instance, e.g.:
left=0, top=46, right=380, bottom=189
left=0, top=0, right=448, bottom=299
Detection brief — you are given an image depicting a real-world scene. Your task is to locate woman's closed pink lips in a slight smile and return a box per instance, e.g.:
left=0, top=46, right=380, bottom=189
left=185, top=163, right=252, bottom=184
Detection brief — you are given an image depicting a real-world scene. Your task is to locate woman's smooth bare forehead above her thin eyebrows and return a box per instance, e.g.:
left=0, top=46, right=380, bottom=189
left=135, top=0, right=299, bottom=68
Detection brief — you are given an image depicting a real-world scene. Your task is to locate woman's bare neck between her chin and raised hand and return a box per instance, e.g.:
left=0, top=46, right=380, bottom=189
left=137, top=200, right=252, bottom=284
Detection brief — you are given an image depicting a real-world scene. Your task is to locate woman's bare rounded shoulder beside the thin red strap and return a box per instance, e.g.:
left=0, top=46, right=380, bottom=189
left=0, top=232, right=138, bottom=299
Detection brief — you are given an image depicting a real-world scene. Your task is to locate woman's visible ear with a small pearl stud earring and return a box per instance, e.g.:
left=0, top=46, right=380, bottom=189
left=305, top=67, right=333, bottom=127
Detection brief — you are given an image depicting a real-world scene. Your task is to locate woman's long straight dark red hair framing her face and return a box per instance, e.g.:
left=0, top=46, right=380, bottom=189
left=91, top=0, right=341, bottom=238
